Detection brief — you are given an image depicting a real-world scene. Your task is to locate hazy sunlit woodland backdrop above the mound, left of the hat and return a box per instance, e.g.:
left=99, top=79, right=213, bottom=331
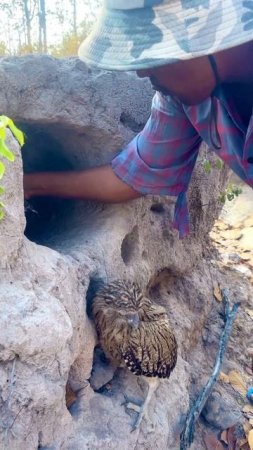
left=0, top=0, right=101, bottom=57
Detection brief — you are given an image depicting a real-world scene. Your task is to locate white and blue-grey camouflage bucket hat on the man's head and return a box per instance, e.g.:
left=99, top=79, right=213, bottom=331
left=78, top=0, right=253, bottom=70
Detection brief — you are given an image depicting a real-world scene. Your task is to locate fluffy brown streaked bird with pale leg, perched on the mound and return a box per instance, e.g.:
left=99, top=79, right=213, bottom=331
left=92, top=280, right=177, bottom=430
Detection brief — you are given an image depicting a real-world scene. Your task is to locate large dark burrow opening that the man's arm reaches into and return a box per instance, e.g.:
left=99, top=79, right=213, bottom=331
left=18, top=123, right=113, bottom=248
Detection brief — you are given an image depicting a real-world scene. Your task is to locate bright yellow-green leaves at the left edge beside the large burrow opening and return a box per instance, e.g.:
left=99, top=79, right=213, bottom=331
left=0, top=116, right=25, bottom=220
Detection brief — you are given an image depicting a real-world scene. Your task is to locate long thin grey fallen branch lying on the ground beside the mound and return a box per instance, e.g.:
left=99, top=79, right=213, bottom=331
left=180, top=289, right=240, bottom=450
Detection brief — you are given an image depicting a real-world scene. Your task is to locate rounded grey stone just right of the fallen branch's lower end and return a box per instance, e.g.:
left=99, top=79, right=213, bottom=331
left=202, top=391, right=242, bottom=430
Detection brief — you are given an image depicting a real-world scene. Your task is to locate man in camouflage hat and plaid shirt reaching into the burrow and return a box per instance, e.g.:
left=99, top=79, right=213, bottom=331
left=24, top=0, right=253, bottom=237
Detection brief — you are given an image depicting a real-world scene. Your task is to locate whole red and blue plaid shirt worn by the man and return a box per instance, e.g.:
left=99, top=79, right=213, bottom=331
left=112, top=85, right=253, bottom=237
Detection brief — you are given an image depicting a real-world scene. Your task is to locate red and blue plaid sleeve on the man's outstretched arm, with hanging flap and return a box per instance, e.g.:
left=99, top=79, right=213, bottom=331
left=112, top=93, right=201, bottom=237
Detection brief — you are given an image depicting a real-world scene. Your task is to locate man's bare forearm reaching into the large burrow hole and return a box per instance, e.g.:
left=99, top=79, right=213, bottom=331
left=24, top=165, right=141, bottom=203
